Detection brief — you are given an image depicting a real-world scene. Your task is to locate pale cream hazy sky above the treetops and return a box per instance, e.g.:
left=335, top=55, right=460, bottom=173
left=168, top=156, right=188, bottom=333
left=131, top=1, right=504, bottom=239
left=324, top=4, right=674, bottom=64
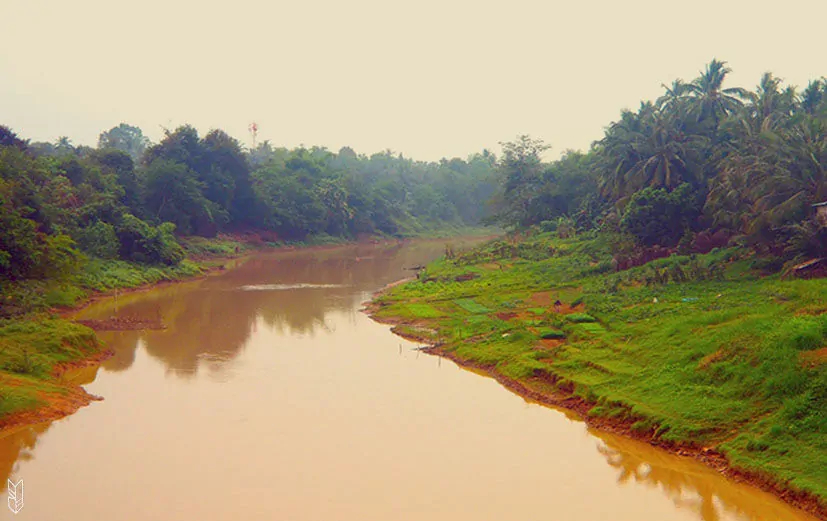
left=0, top=0, right=827, bottom=159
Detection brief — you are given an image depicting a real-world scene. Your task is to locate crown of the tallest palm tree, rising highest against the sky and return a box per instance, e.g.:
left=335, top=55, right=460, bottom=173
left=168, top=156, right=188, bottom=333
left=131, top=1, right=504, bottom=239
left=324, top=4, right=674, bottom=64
left=687, top=59, right=746, bottom=128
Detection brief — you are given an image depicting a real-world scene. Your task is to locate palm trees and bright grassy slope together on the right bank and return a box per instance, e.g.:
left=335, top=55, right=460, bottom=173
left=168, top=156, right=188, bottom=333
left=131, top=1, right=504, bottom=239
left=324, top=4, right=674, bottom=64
left=376, top=60, right=827, bottom=501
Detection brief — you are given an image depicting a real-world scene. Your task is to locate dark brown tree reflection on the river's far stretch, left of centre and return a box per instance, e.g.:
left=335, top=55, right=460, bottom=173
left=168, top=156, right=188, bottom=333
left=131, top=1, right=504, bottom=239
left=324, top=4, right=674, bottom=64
left=76, top=241, right=466, bottom=378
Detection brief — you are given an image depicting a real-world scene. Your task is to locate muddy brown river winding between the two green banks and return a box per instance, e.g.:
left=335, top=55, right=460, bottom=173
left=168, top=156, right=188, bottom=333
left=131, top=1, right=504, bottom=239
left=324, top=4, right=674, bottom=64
left=0, top=241, right=814, bottom=521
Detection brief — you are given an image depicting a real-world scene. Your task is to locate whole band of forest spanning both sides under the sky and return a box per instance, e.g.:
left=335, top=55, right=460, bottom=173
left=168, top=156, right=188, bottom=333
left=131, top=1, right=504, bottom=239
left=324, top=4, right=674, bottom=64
left=0, top=60, right=827, bottom=312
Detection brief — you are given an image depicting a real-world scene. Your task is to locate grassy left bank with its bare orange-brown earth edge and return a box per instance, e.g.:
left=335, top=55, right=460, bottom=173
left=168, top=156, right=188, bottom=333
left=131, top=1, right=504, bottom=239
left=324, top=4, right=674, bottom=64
left=0, top=237, right=268, bottom=429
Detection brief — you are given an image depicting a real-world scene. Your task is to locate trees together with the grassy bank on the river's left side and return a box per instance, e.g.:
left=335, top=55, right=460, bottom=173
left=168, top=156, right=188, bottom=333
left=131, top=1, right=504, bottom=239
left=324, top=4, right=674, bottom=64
left=0, top=124, right=495, bottom=421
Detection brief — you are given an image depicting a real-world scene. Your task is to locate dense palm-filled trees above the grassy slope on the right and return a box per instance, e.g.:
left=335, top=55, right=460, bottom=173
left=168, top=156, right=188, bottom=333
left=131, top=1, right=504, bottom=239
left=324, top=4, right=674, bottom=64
left=496, top=60, right=827, bottom=258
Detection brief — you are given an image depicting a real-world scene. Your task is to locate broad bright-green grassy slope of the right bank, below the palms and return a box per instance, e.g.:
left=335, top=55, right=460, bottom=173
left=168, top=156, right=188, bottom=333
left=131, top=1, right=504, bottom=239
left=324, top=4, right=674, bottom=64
left=372, top=234, right=827, bottom=516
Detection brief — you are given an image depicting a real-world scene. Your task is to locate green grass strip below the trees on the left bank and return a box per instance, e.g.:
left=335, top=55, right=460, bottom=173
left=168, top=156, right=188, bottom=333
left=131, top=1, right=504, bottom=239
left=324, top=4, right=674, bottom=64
left=0, top=234, right=252, bottom=417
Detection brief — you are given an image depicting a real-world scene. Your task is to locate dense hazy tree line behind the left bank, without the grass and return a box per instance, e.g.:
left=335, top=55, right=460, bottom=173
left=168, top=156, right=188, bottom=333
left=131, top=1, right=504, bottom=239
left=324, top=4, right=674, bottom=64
left=0, top=124, right=496, bottom=282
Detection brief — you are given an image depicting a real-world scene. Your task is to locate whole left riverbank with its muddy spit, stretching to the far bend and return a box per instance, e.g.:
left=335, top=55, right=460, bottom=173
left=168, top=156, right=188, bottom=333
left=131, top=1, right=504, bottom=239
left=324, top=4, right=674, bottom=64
left=0, top=233, right=492, bottom=436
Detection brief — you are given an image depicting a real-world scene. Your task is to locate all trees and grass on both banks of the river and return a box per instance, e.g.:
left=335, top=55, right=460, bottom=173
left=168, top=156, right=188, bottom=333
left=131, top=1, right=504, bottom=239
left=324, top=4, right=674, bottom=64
left=0, top=60, right=827, bottom=508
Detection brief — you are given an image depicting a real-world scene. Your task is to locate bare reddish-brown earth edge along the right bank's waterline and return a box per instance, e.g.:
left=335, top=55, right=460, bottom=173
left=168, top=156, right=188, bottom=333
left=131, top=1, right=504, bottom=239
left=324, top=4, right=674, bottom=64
left=363, top=304, right=827, bottom=520
